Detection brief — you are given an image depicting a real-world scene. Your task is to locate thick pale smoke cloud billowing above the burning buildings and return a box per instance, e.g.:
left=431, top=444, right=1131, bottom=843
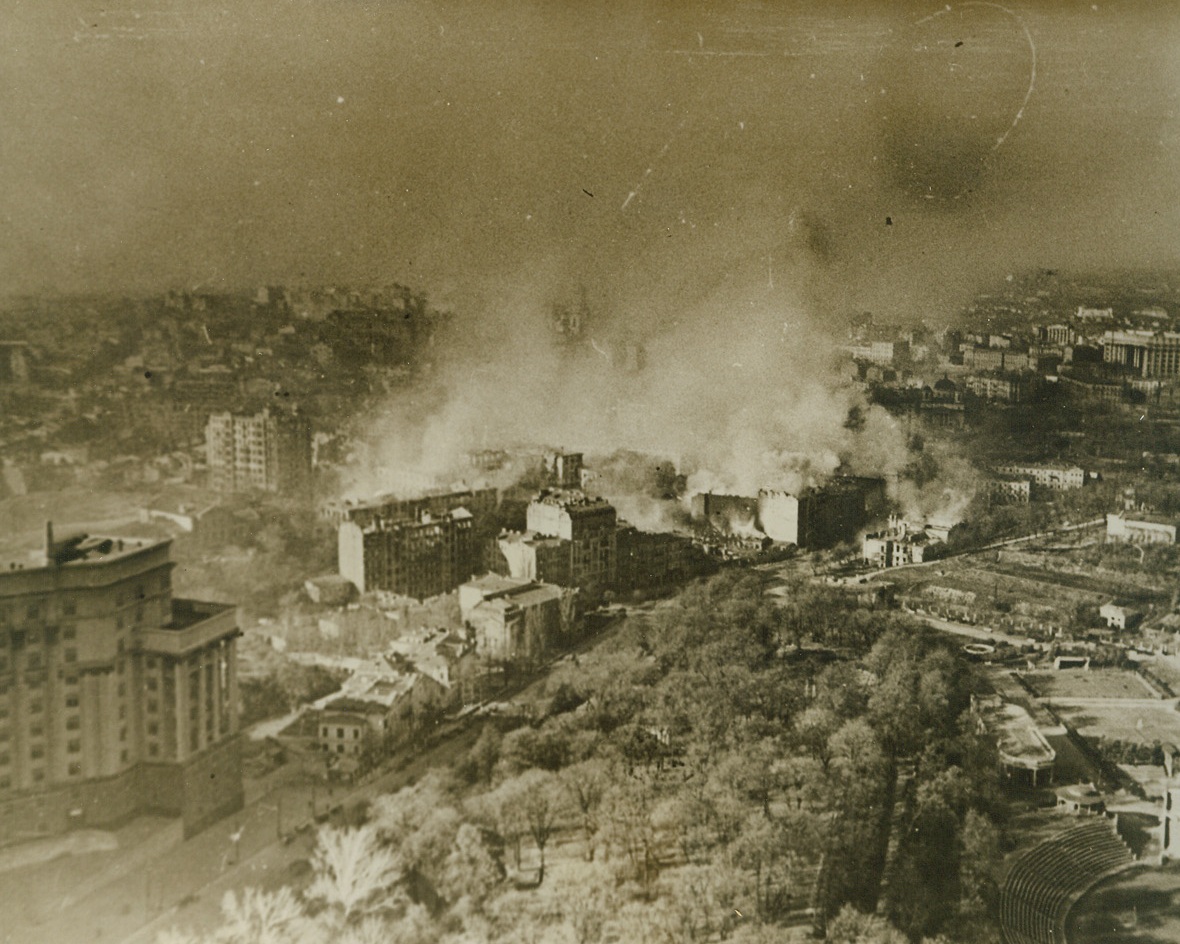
left=342, top=248, right=929, bottom=519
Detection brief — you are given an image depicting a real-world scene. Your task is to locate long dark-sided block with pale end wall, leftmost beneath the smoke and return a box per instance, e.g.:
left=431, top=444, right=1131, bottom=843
left=336, top=507, right=480, bottom=599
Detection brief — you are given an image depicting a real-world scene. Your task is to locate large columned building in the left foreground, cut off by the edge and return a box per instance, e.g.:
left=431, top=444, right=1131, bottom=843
left=0, top=529, right=242, bottom=843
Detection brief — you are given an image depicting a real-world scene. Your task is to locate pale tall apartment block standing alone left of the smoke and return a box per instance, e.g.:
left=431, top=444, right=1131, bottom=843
left=205, top=407, right=312, bottom=492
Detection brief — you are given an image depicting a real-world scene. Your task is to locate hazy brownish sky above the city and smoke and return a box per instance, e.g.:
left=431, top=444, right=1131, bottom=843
left=0, top=0, right=1180, bottom=320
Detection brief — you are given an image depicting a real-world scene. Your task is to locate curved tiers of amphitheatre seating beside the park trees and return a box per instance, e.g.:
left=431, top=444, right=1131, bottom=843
left=999, top=818, right=1134, bottom=944
